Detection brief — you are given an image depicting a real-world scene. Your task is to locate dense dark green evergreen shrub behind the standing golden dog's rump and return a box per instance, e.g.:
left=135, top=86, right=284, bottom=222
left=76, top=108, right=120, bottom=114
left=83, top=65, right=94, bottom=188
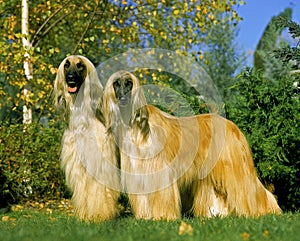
left=228, top=70, right=300, bottom=210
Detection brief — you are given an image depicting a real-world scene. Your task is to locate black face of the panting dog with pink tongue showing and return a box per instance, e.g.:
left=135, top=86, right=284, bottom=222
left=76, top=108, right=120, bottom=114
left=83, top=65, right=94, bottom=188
left=64, top=58, right=87, bottom=94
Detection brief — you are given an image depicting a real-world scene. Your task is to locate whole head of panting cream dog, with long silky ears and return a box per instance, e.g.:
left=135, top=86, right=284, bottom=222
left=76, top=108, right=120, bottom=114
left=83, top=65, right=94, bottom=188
left=53, top=55, right=104, bottom=123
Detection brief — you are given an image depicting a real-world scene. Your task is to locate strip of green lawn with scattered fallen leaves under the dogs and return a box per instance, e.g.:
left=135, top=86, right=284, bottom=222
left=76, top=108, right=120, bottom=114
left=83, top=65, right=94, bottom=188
left=0, top=209, right=300, bottom=241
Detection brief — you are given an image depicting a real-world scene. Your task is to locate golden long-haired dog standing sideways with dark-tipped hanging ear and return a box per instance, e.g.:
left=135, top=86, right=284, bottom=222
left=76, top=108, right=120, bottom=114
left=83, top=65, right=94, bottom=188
left=103, top=71, right=281, bottom=220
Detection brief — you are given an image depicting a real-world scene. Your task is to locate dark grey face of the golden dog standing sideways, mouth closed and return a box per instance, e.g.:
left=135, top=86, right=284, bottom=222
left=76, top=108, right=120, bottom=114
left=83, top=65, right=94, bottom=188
left=113, top=76, right=133, bottom=107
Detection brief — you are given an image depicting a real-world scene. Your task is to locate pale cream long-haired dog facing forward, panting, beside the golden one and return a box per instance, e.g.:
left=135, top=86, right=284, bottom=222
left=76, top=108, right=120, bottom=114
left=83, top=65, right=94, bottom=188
left=54, top=55, right=120, bottom=222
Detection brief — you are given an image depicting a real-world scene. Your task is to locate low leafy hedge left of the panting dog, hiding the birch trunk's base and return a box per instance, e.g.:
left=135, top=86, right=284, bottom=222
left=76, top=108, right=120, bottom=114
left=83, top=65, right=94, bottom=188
left=0, top=124, right=66, bottom=206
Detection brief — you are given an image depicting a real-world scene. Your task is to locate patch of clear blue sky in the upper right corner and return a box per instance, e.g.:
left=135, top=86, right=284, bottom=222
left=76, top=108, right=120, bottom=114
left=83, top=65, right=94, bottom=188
left=237, top=0, right=300, bottom=65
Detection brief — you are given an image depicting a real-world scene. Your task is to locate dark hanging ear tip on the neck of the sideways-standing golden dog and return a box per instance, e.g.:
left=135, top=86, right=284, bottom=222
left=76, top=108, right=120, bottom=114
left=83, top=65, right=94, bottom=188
left=130, top=105, right=150, bottom=136
